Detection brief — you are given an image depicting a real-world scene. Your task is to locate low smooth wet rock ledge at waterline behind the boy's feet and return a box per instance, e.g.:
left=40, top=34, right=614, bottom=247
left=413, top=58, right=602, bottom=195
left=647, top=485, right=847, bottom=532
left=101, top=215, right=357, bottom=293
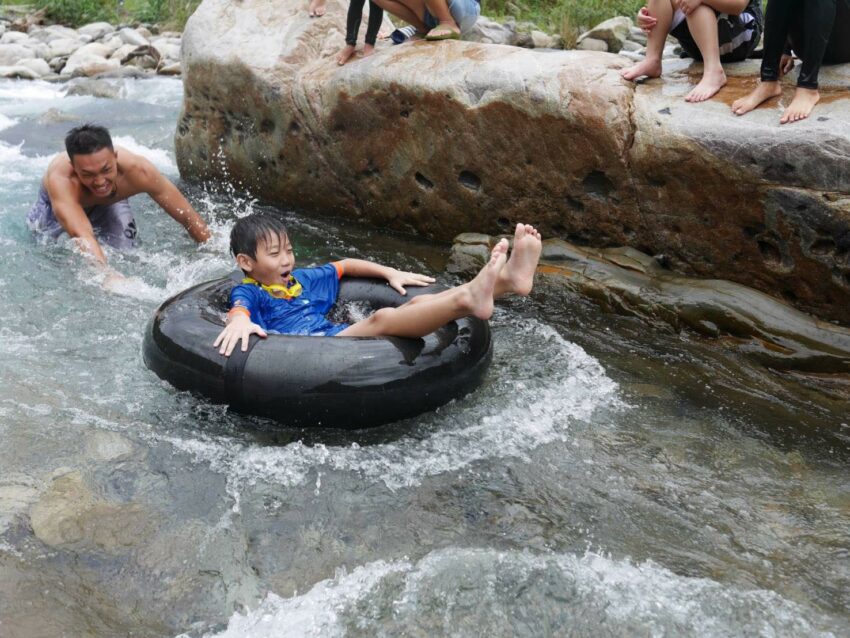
left=450, top=236, right=850, bottom=375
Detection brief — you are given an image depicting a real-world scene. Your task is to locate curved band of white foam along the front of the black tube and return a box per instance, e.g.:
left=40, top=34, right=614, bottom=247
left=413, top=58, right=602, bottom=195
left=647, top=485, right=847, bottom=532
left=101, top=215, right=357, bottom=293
left=162, top=320, right=617, bottom=492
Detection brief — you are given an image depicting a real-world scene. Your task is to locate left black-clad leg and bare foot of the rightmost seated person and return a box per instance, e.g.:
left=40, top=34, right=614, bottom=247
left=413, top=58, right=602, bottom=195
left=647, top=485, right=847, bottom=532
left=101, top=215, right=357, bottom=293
left=732, top=0, right=803, bottom=115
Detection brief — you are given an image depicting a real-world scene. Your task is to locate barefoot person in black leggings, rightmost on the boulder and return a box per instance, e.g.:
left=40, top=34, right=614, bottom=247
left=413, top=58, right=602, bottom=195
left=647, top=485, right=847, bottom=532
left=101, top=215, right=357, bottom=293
left=732, top=0, right=850, bottom=124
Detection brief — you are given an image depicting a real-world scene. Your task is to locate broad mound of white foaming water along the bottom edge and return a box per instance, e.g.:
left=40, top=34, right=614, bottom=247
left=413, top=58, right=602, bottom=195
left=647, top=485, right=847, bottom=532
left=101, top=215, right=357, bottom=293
left=194, top=548, right=833, bottom=638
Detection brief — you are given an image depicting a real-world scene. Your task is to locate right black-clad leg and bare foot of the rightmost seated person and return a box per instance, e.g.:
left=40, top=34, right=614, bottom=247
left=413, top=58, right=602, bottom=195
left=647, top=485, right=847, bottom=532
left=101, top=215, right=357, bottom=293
left=779, top=0, right=836, bottom=124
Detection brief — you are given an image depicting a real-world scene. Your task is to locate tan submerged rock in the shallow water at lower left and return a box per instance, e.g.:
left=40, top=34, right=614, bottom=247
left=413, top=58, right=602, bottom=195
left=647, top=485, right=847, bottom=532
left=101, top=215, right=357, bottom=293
left=30, top=472, right=154, bottom=553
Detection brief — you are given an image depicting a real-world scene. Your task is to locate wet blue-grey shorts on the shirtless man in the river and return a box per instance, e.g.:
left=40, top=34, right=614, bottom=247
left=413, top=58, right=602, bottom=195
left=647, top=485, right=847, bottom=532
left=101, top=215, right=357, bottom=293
left=27, top=185, right=137, bottom=250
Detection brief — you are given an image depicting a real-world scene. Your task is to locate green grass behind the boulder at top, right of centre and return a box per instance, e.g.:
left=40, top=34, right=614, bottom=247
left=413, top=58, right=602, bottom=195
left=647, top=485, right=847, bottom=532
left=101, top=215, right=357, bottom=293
left=482, top=0, right=646, bottom=46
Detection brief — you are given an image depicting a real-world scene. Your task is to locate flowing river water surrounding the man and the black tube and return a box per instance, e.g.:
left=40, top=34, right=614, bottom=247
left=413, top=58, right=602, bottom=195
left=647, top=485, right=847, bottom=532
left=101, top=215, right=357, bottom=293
left=0, top=79, right=850, bottom=638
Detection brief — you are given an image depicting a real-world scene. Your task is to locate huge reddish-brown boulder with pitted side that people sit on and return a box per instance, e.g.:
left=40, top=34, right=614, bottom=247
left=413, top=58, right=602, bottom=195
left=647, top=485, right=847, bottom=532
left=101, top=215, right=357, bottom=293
left=176, top=0, right=850, bottom=323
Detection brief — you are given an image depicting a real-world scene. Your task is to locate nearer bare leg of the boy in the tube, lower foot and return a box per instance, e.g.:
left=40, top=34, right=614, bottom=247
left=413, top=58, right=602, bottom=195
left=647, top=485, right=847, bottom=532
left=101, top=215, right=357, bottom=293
left=336, top=240, right=508, bottom=338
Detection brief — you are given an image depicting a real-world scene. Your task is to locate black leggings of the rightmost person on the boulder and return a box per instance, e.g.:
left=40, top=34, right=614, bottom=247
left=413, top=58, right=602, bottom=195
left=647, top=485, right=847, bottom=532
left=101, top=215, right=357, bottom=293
left=761, top=0, right=850, bottom=89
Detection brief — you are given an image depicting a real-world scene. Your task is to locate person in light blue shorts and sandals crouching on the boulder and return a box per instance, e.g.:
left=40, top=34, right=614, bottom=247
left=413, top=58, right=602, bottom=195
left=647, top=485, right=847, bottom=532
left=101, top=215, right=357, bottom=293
left=374, top=0, right=481, bottom=43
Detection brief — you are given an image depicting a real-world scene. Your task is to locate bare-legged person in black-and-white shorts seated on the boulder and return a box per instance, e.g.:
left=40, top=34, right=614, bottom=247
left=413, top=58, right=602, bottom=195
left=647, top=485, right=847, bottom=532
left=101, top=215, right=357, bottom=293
left=621, top=0, right=762, bottom=102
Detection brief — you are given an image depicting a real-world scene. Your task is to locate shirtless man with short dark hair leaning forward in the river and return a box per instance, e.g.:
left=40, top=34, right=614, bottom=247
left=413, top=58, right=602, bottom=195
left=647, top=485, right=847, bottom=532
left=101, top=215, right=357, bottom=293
left=27, top=124, right=210, bottom=284
